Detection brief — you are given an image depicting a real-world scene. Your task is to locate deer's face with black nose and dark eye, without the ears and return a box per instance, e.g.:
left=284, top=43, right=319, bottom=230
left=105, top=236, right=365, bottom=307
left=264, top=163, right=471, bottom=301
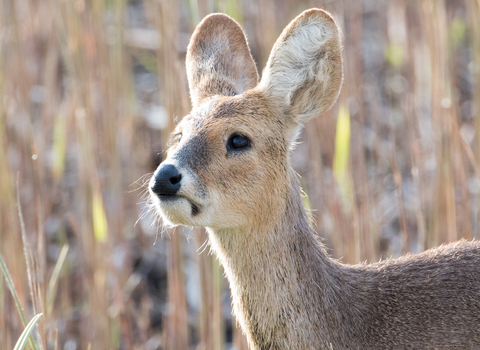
left=151, top=91, right=288, bottom=228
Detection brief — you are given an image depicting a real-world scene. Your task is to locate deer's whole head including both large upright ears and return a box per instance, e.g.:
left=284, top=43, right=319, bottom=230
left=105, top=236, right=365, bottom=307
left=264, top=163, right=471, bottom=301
left=150, top=10, right=342, bottom=229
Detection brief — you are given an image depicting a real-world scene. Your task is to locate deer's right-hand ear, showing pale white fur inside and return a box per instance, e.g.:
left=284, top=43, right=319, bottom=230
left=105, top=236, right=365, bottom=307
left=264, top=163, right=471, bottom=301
left=259, top=9, right=343, bottom=123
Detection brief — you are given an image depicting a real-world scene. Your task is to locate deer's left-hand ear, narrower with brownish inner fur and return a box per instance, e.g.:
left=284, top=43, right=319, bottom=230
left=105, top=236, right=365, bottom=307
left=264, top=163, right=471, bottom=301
left=187, top=13, right=258, bottom=107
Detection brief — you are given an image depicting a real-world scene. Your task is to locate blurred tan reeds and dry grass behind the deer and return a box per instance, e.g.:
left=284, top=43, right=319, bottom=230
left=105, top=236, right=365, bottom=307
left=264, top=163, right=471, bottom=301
left=0, top=0, right=480, bottom=350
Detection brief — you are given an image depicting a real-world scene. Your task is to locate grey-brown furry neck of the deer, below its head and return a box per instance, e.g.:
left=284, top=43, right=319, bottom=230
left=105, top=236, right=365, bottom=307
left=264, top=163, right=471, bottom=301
left=207, top=171, right=373, bottom=349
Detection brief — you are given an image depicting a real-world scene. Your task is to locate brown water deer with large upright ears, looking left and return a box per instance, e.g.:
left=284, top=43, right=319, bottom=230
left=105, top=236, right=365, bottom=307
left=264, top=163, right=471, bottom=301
left=149, top=9, right=480, bottom=350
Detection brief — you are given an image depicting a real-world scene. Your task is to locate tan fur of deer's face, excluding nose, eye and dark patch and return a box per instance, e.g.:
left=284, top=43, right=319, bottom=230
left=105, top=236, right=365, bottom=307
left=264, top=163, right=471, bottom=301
left=154, top=90, right=293, bottom=229
